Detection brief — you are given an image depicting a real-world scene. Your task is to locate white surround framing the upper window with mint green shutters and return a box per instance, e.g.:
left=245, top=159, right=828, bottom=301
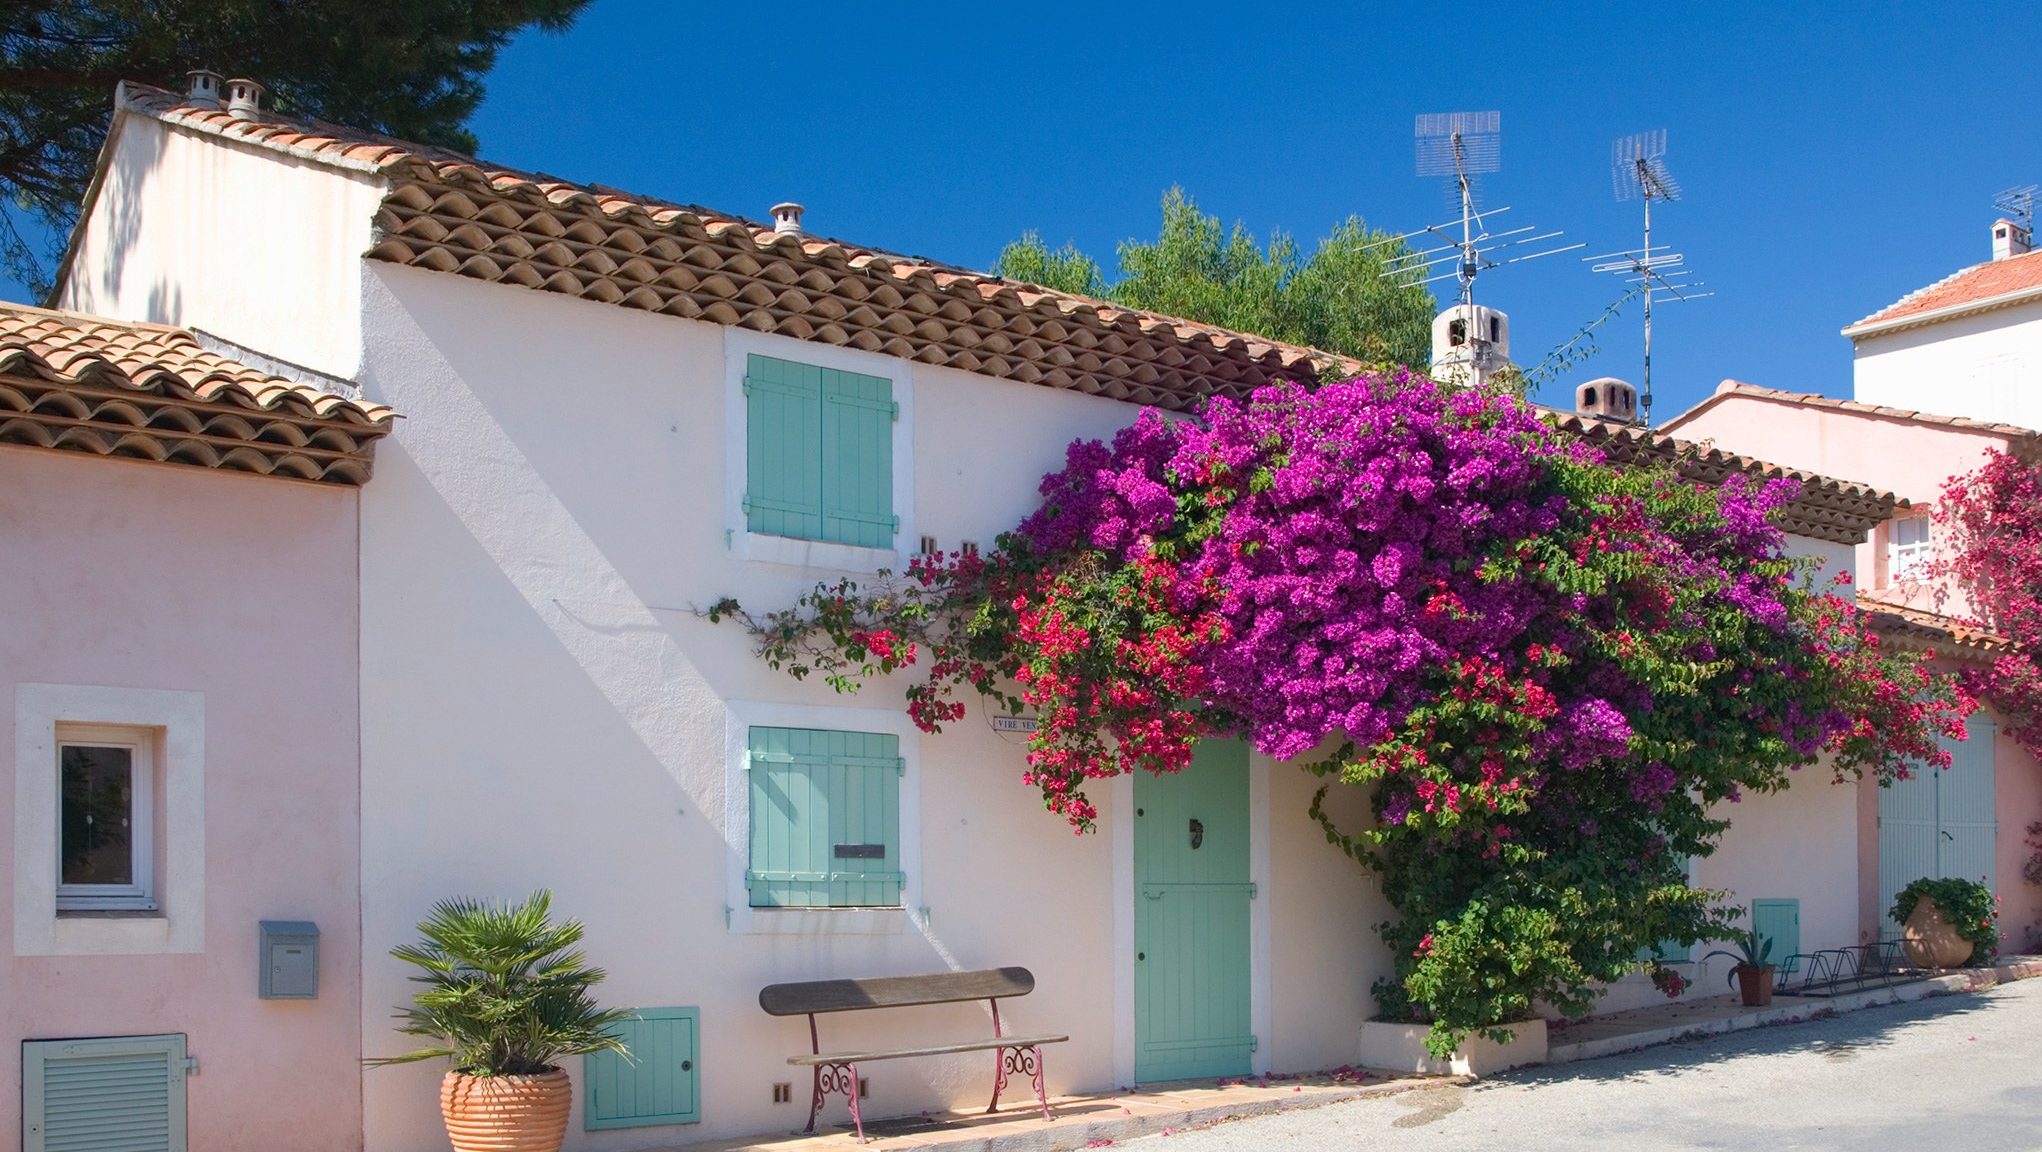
left=721, top=329, right=921, bottom=572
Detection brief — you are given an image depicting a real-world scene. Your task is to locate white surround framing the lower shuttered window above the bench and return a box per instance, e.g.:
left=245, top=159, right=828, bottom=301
left=723, top=701, right=927, bottom=935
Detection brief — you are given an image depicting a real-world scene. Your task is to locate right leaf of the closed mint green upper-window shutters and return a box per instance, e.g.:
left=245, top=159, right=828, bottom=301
left=823, top=368, right=898, bottom=547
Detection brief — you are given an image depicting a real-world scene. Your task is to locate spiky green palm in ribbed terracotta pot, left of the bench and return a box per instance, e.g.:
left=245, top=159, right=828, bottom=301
left=370, top=891, right=631, bottom=1152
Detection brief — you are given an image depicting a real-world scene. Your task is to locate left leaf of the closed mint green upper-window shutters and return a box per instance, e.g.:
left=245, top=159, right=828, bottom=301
left=745, top=355, right=823, bottom=539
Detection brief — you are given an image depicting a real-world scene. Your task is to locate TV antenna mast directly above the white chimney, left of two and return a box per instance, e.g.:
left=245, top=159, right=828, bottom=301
left=1362, top=112, right=1587, bottom=304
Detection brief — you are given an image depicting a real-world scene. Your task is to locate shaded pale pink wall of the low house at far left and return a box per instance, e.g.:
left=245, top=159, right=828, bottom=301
left=0, top=447, right=361, bottom=1152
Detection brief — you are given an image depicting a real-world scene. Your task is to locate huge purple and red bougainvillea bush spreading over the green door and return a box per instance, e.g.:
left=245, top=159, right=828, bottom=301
left=717, top=374, right=1968, bottom=1052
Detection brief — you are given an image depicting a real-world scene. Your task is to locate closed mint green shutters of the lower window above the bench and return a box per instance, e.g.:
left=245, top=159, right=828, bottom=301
left=745, top=727, right=903, bottom=907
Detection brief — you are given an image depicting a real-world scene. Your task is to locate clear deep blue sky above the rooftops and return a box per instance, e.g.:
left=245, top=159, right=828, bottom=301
left=6, top=0, right=2042, bottom=417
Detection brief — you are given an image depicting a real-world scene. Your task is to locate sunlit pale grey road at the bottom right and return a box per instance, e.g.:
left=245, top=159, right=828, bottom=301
left=1135, top=980, right=2042, bottom=1152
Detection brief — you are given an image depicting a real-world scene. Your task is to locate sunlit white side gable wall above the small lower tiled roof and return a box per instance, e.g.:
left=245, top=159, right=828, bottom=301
left=55, top=114, right=382, bottom=378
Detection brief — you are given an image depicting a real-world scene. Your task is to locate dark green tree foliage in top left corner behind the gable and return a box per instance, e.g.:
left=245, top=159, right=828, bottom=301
left=0, top=0, right=588, bottom=290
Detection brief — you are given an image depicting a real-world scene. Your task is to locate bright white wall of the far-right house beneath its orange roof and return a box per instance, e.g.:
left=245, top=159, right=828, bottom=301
left=1852, top=300, right=2042, bottom=429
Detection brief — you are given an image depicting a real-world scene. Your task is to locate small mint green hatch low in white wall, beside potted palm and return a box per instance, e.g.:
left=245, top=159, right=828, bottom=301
left=582, top=1007, right=702, bottom=1132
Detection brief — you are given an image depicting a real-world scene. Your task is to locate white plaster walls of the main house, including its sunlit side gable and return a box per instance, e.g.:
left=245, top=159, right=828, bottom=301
left=47, top=94, right=1886, bottom=1152
